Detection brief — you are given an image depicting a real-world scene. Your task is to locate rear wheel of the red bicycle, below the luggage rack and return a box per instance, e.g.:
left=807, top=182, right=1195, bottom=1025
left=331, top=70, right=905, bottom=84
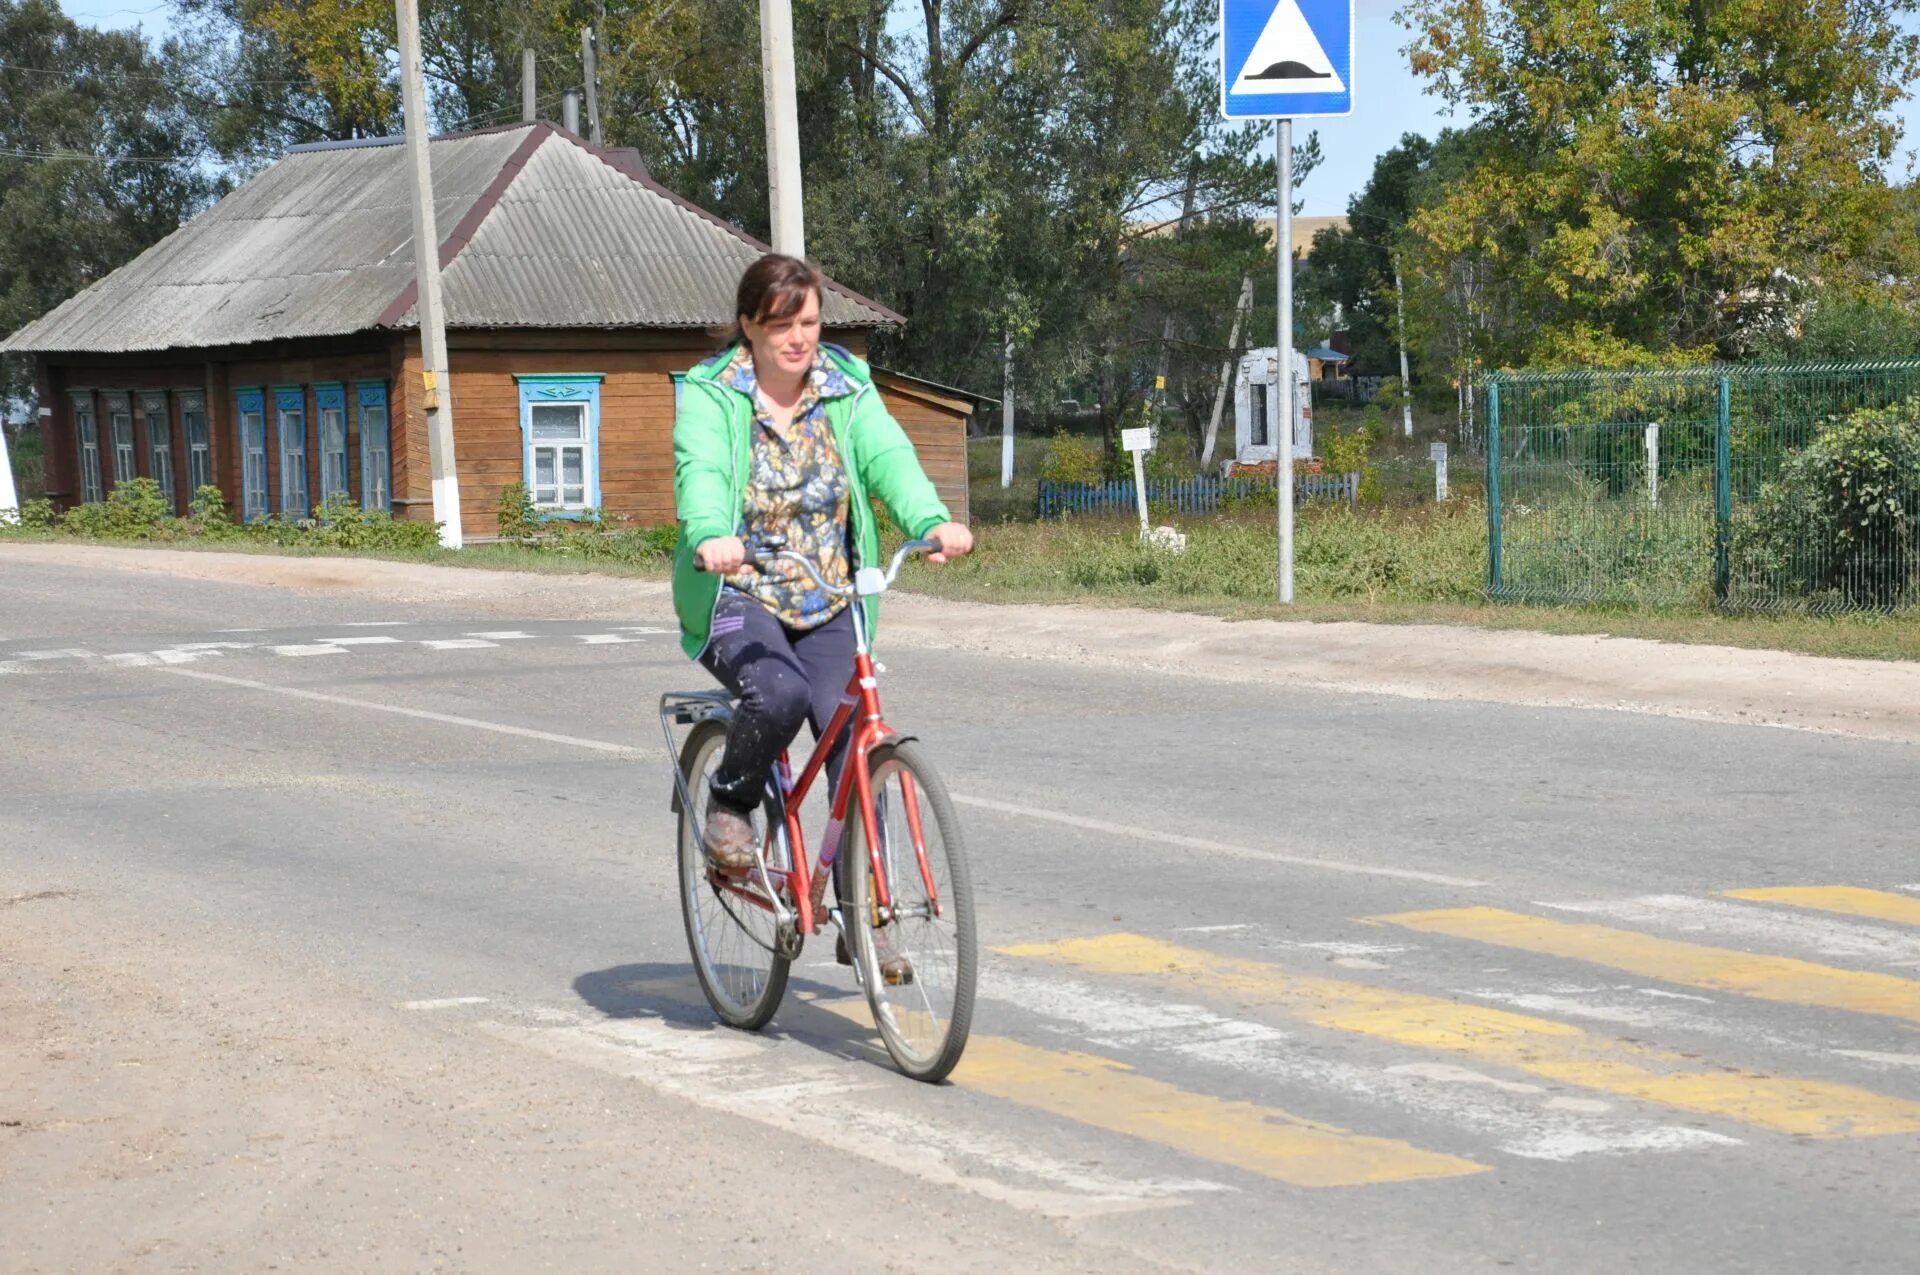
left=680, top=718, right=791, bottom=1031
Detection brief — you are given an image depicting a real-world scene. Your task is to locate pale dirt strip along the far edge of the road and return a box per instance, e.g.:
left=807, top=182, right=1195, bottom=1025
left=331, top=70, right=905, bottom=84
left=15, top=543, right=1920, bottom=743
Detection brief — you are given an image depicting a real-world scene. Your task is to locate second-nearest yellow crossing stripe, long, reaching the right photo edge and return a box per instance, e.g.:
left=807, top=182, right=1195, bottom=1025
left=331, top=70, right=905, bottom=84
left=995, top=933, right=1920, bottom=1137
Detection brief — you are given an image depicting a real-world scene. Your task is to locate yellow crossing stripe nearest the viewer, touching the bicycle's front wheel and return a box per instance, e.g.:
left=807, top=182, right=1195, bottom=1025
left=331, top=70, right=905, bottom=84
left=814, top=998, right=1486, bottom=1187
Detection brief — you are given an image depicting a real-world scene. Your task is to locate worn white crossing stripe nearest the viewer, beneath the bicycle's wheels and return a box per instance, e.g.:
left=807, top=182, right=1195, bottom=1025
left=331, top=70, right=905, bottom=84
left=480, top=1018, right=1231, bottom=1219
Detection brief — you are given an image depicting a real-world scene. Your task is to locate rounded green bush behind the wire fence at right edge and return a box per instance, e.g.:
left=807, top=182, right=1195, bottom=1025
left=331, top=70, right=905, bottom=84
left=1734, top=399, right=1920, bottom=609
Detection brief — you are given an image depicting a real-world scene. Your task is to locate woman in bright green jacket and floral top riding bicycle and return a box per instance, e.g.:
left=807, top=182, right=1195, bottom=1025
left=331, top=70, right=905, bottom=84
left=674, top=253, right=973, bottom=872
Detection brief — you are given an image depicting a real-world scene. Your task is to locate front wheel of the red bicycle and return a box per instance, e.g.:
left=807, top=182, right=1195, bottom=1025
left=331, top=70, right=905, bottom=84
left=841, top=739, right=979, bottom=1083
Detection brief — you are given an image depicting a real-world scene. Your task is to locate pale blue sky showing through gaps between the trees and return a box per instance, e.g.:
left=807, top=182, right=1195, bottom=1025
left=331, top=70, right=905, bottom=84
left=52, top=0, right=1920, bottom=217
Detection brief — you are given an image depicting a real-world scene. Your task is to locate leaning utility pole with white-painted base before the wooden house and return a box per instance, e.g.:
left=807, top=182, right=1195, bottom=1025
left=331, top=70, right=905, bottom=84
left=394, top=0, right=463, bottom=549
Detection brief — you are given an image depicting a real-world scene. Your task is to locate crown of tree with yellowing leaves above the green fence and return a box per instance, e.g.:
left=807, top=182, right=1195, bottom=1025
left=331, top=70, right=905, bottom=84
left=1400, top=0, right=1920, bottom=361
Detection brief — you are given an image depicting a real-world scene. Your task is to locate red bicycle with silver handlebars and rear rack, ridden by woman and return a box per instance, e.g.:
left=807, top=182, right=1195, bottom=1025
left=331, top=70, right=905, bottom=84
left=660, top=540, right=979, bottom=1083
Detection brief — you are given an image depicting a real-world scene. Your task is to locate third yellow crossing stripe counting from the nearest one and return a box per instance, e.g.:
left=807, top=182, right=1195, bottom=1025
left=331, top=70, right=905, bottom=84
left=1369, top=908, right=1920, bottom=1023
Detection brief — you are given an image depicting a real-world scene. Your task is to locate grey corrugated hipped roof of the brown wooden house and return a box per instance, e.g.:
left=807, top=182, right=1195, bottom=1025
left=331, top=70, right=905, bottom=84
left=0, top=125, right=900, bottom=351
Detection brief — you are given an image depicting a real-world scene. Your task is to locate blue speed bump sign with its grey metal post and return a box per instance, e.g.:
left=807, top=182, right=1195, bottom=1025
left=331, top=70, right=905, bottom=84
left=1219, top=0, right=1354, bottom=603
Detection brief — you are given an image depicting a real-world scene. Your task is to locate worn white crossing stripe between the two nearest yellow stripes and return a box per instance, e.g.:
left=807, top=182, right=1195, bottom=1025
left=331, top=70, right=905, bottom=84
left=981, top=966, right=1740, bottom=1160
